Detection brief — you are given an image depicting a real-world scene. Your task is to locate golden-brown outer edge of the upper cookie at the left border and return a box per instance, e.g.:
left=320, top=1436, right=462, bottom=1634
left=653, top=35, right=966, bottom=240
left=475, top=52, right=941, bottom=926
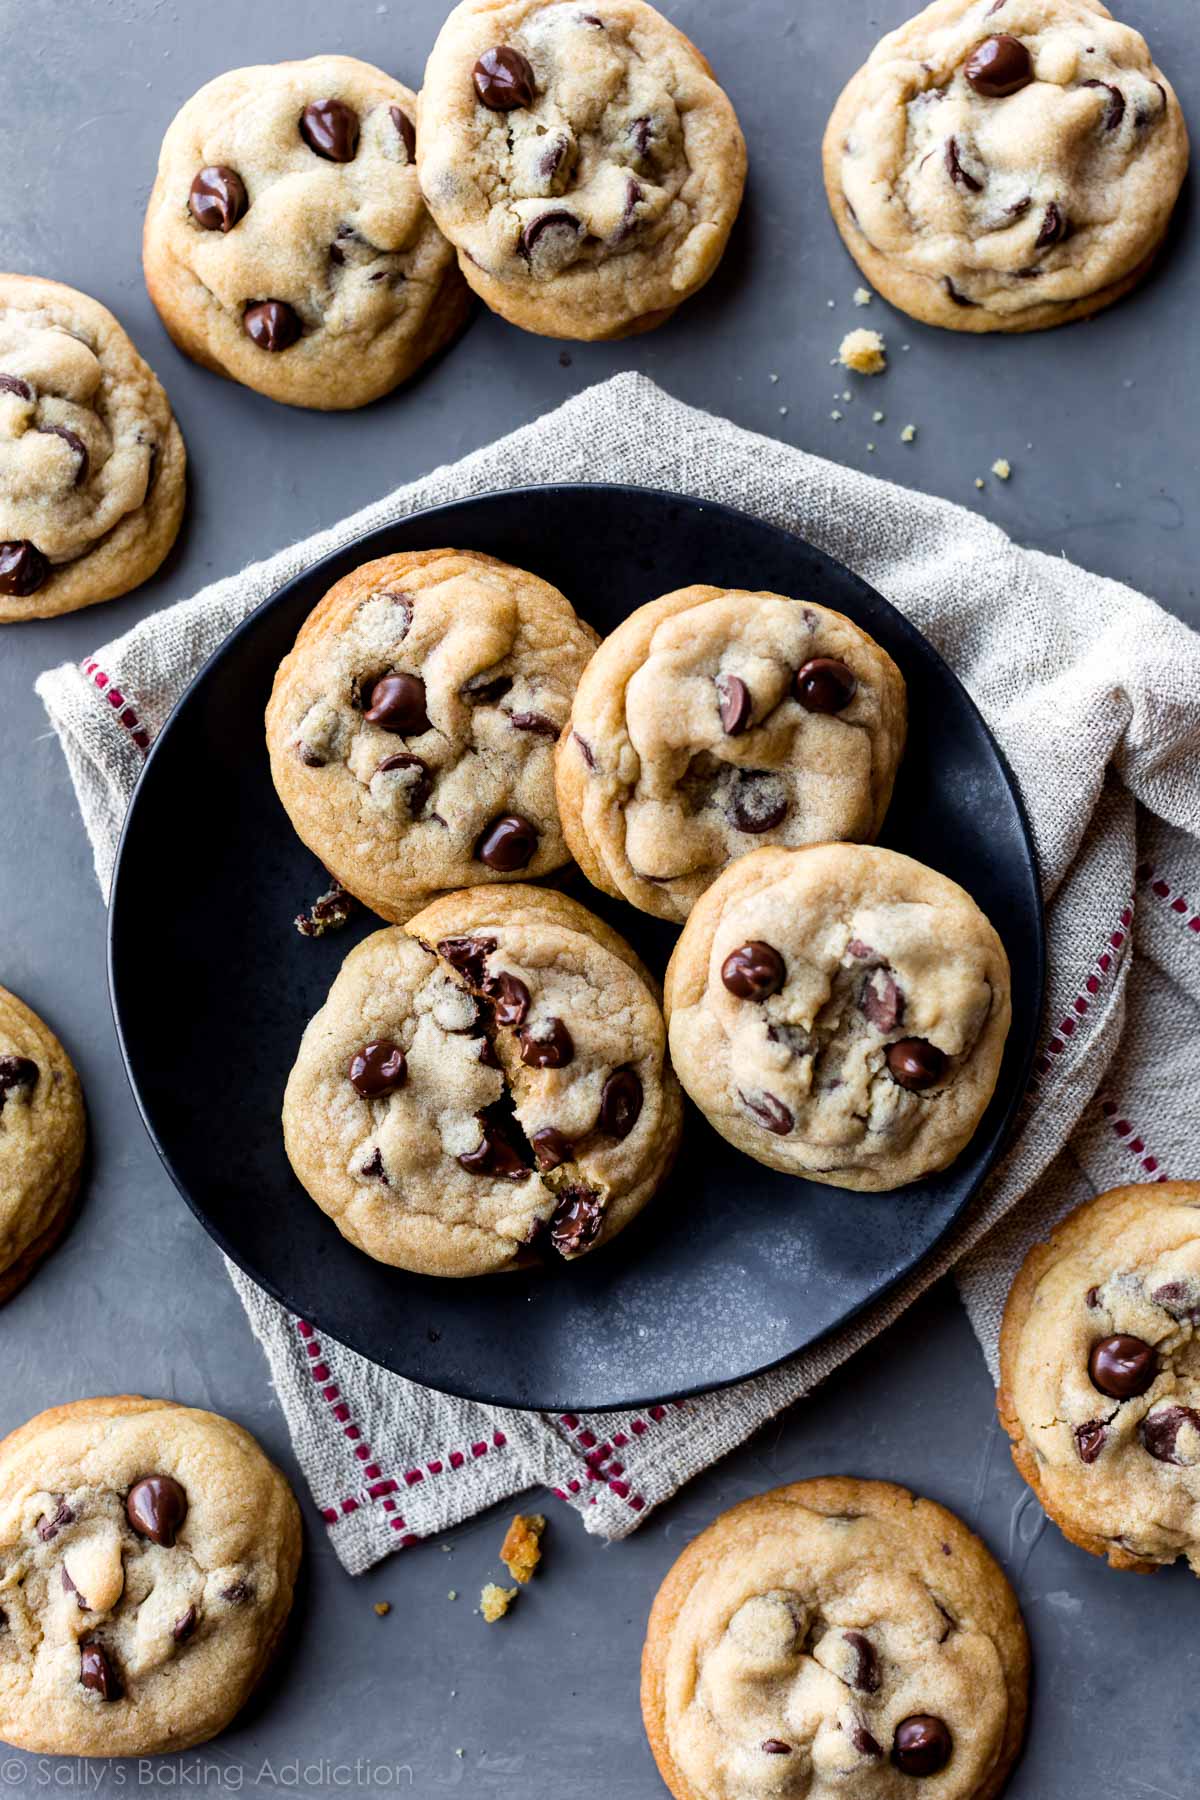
left=0, top=274, right=187, bottom=625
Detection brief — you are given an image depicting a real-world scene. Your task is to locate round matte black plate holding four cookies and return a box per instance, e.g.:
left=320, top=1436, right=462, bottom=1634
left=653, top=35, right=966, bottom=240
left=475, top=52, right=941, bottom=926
left=110, top=486, right=1043, bottom=1411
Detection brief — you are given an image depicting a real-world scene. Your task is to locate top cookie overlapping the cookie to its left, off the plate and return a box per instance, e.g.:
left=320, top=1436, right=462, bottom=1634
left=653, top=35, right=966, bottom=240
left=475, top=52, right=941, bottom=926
left=417, top=0, right=747, bottom=338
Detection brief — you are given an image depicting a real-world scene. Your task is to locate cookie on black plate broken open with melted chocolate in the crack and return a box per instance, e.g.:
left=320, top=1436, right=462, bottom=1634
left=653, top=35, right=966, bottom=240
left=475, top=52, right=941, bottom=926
left=282, top=887, right=682, bottom=1276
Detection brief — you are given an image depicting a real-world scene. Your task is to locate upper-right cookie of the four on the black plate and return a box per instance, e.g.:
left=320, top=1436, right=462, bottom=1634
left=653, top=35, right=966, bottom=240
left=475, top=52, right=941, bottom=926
left=556, top=587, right=905, bottom=920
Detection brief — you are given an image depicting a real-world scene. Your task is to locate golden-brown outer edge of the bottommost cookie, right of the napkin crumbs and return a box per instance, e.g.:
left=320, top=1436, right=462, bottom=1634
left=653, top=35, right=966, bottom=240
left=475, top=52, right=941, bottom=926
left=640, top=1476, right=1029, bottom=1800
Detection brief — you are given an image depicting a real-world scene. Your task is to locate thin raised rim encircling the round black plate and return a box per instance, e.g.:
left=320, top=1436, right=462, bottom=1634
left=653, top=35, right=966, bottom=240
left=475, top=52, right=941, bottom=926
left=104, top=481, right=1047, bottom=1413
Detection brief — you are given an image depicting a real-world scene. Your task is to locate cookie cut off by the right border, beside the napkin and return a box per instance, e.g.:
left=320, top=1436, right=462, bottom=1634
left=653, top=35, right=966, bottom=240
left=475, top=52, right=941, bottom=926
left=997, top=1181, right=1200, bottom=1575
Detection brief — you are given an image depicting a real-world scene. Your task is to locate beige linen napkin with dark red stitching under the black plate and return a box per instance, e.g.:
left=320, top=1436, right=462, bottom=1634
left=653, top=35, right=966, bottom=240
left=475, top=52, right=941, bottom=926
left=38, top=374, right=1200, bottom=1573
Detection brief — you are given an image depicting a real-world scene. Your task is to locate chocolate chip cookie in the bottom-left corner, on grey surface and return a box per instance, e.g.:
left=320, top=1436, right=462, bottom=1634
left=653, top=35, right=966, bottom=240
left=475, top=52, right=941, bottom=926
left=0, top=1393, right=300, bottom=1757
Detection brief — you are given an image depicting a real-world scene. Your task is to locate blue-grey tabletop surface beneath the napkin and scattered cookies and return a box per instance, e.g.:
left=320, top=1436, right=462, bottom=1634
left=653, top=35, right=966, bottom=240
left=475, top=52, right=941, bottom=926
left=0, top=0, right=1200, bottom=1800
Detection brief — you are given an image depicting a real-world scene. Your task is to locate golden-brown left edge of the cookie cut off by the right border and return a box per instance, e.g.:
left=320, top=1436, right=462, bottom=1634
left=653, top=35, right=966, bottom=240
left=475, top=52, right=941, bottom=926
left=997, top=1181, right=1200, bottom=1575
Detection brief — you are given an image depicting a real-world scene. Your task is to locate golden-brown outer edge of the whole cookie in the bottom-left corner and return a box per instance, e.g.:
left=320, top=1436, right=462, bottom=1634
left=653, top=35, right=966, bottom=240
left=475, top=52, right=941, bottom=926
left=0, top=1393, right=304, bottom=1757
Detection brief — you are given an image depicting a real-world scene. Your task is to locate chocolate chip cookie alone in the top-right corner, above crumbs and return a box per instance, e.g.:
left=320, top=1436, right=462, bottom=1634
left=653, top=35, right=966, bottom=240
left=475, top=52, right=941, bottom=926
left=824, top=0, right=1187, bottom=331
